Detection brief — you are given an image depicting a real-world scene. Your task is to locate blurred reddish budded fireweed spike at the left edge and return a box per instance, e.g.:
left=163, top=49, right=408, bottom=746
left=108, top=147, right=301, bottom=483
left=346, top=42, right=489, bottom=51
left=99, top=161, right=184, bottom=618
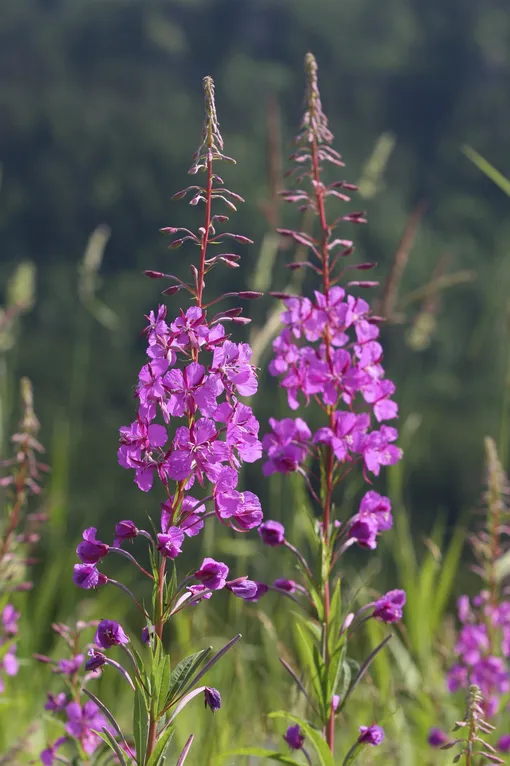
left=0, top=378, right=48, bottom=694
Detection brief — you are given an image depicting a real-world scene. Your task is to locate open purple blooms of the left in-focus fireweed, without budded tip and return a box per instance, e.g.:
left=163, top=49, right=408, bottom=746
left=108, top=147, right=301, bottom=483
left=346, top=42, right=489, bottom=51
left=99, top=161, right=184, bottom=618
left=118, top=306, right=262, bottom=498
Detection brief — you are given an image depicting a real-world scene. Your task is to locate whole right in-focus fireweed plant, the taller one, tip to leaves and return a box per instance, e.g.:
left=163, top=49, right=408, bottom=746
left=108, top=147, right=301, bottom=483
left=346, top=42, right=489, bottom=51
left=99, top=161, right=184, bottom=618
left=229, top=54, right=405, bottom=764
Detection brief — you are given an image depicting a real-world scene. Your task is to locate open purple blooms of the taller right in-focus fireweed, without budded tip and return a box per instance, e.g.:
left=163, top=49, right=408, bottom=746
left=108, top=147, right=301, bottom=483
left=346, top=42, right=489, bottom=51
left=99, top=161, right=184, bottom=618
left=263, top=286, right=402, bottom=476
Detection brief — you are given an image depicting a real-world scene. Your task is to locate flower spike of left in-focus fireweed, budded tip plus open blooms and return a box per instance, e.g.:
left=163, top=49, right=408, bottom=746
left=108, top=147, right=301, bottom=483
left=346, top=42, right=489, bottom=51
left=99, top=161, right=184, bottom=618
left=114, top=78, right=262, bottom=558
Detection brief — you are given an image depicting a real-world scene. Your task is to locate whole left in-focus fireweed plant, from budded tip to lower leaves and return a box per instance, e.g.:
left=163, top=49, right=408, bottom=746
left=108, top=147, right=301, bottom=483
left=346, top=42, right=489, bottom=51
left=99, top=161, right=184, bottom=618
left=66, top=77, right=262, bottom=766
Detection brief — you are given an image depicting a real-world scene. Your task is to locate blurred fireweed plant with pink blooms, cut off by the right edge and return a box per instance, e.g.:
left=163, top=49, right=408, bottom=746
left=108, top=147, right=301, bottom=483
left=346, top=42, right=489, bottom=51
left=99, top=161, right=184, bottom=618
left=428, top=438, right=510, bottom=763
